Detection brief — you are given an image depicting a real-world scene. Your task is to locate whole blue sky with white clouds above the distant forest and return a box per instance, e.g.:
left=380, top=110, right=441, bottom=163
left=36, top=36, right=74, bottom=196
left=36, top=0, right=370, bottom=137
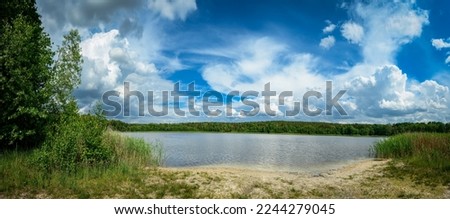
left=37, top=0, right=450, bottom=124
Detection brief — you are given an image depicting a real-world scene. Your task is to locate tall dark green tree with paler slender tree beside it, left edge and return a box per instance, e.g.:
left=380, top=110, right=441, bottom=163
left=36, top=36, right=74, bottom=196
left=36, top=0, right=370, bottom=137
left=0, top=0, right=82, bottom=149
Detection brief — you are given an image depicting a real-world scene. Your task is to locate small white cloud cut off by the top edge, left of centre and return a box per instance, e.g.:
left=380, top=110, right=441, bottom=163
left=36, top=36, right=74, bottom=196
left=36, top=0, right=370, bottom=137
left=148, top=0, right=197, bottom=20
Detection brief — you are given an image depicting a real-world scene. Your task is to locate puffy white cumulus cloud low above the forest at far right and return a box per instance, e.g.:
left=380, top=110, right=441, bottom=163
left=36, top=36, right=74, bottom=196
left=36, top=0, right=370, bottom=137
left=346, top=65, right=449, bottom=119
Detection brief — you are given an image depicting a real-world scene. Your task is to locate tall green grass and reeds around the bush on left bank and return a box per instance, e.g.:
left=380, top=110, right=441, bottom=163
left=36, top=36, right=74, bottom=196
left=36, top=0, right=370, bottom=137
left=0, top=131, right=163, bottom=198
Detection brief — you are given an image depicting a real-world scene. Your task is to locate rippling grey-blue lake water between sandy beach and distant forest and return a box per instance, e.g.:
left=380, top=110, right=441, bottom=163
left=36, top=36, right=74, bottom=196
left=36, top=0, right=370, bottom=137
left=126, top=132, right=382, bottom=171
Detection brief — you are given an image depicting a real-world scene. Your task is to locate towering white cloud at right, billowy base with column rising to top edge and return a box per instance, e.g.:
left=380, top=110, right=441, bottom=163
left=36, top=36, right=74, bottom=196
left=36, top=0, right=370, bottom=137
left=336, top=2, right=450, bottom=122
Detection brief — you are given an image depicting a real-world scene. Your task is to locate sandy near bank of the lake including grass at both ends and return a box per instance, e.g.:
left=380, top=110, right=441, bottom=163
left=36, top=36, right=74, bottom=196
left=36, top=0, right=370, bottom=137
left=0, top=134, right=450, bottom=198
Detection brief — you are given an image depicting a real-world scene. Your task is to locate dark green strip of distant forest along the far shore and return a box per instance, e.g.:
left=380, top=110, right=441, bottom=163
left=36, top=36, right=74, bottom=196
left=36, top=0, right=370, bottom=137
left=109, top=120, right=450, bottom=136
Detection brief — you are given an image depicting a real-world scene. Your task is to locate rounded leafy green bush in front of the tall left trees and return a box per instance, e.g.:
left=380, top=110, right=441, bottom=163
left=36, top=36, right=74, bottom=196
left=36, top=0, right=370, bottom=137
left=35, top=115, right=110, bottom=172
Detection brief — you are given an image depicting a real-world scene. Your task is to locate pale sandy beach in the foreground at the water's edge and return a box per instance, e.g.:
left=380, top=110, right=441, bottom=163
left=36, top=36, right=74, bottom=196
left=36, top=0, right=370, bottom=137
left=152, top=160, right=450, bottom=198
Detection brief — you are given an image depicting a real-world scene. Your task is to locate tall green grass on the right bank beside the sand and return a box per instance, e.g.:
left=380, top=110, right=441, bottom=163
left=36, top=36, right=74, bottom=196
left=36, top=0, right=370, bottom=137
left=374, top=133, right=450, bottom=186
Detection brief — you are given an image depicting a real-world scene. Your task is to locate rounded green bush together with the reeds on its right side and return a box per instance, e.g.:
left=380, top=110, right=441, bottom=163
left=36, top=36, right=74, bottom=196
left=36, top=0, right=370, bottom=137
left=34, top=111, right=163, bottom=173
